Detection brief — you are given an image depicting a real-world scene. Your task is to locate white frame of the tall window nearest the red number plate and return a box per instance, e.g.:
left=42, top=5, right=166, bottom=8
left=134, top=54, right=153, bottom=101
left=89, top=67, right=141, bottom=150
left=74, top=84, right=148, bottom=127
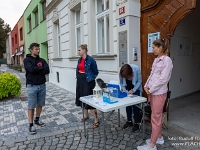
left=95, top=0, right=110, bottom=54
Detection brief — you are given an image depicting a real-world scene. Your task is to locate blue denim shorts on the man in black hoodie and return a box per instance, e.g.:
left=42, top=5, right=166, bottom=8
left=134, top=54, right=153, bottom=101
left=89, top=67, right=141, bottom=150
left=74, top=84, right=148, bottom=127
left=27, top=84, right=46, bottom=109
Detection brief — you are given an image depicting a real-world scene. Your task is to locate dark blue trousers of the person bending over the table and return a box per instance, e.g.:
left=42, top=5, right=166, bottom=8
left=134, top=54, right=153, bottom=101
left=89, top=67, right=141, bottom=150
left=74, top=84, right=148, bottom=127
left=126, top=90, right=140, bottom=123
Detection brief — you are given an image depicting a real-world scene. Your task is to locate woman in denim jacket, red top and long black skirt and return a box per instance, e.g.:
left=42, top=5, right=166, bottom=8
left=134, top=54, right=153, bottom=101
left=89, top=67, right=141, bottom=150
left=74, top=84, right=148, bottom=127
left=75, top=44, right=100, bottom=128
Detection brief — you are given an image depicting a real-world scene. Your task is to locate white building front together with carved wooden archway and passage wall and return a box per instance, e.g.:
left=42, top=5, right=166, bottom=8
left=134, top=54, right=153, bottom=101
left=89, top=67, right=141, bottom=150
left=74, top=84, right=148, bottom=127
left=46, top=0, right=200, bottom=101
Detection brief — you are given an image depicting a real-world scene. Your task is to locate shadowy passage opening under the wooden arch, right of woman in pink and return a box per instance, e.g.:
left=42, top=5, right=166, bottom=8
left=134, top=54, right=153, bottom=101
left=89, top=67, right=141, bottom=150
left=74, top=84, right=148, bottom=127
left=169, top=1, right=200, bottom=135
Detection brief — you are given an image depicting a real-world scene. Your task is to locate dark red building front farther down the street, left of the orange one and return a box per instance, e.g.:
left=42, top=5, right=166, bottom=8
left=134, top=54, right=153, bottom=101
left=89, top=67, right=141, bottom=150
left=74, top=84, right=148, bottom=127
left=11, top=24, right=20, bottom=64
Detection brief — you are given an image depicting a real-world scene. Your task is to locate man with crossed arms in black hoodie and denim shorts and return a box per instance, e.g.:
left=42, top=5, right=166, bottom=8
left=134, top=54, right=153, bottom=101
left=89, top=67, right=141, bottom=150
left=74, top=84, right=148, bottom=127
left=24, top=43, right=49, bottom=134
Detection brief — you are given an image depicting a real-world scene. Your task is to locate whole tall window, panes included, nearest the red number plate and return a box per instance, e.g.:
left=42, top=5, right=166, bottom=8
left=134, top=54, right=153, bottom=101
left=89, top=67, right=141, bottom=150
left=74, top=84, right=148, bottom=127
left=96, top=0, right=110, bottom=54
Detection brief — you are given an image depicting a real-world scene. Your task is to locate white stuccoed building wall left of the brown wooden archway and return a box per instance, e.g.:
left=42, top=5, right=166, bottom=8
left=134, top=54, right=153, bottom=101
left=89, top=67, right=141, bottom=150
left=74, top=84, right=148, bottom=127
left=45, top=0, right=141, bottom=92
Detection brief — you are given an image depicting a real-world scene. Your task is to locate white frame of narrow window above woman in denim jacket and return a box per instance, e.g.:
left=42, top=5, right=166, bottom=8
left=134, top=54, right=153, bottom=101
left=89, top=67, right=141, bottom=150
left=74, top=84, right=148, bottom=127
left=75, top=8, right=82, bottom=55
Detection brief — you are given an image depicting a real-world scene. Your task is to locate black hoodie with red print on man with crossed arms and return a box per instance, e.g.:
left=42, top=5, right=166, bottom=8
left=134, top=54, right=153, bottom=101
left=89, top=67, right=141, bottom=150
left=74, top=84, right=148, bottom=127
left=24, top=54, right=49, bottom=85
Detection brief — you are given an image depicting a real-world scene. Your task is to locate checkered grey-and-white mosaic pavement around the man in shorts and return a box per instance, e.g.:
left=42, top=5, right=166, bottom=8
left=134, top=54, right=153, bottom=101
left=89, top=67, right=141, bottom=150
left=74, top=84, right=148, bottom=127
left=0, top=66, right=87, bottom=141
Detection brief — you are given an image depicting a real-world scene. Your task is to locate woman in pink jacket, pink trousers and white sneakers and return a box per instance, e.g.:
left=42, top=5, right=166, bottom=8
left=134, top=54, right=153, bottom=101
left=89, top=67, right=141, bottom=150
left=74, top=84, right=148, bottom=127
left=137, top=39, right=173, bottom=150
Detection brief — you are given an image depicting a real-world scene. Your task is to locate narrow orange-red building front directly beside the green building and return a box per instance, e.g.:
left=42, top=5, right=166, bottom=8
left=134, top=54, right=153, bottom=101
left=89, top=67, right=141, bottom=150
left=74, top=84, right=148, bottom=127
left=16, top=15, right=25, bottom=65
